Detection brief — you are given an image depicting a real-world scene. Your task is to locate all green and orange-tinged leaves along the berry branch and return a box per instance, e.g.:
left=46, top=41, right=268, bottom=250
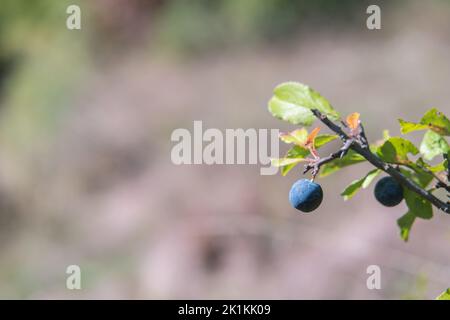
left=268, top=82, right=450, bottom=241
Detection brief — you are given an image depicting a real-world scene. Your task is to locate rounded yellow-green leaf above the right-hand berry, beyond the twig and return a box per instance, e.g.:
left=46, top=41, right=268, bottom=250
left=377, top=137, right=419, bottom=164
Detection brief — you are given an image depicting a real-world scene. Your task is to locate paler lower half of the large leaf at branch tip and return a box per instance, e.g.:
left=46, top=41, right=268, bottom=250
left=269, top=97, right=316, bottom=126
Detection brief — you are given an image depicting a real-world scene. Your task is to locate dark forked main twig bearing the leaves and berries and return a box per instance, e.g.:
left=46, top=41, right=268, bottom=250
left=312, top=109, right=450, bottom=214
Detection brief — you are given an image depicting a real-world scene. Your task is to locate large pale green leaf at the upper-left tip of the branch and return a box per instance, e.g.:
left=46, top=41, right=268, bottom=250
left=269, top=82, right=339, bottom=126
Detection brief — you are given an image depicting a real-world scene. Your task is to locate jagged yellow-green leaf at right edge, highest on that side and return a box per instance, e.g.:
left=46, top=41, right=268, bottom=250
left=398, top=108, right=450, bottom=136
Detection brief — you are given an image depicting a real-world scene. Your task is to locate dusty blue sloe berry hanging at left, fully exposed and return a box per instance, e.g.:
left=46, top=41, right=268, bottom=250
left=289, top=179, right=323, bottom=212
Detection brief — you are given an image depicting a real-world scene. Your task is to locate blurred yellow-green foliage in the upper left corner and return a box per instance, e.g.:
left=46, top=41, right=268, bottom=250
left=0, top=0, right=87, bottom=148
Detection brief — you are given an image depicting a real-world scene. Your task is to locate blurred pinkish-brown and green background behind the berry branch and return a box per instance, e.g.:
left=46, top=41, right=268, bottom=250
left=0, top=0, right=450, bottom=299
